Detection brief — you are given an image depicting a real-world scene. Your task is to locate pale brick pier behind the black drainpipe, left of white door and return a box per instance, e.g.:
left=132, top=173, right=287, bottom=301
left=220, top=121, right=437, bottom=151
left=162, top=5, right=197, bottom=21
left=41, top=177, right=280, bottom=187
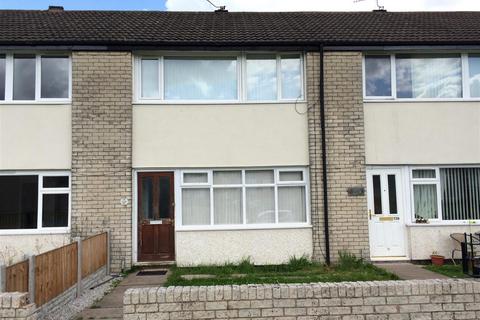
left=307, top=52, right=369, bottom=260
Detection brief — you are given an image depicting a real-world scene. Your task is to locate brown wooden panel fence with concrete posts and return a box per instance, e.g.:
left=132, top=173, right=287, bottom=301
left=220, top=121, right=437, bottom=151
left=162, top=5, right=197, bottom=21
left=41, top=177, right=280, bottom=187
left=0, top=232, right=110, bottom=307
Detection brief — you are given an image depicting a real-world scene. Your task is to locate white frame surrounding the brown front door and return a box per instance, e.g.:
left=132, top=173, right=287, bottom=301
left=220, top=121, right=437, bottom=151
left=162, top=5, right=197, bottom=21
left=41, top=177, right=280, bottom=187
left=131, top=168, right=179, bottom=266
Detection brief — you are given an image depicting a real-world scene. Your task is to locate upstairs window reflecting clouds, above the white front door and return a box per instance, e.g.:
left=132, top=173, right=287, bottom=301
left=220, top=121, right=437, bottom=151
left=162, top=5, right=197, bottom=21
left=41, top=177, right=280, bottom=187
left=364, top=53, right=480, bottom=100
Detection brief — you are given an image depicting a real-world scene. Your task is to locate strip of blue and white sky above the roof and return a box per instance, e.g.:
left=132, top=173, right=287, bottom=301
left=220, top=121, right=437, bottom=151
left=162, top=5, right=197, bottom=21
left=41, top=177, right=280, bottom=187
left=0, top=0, right=480, bottom=11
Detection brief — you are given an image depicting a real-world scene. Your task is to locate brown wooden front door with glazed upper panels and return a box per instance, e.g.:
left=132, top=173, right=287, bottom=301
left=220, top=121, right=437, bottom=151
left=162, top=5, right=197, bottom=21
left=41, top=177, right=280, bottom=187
left=138, top=172, right=175, bottom=261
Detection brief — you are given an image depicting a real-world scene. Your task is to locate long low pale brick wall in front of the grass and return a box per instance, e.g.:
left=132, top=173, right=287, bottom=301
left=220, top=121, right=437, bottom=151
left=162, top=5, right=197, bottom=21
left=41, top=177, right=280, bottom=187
left=124, top=279, right=480, bottom=320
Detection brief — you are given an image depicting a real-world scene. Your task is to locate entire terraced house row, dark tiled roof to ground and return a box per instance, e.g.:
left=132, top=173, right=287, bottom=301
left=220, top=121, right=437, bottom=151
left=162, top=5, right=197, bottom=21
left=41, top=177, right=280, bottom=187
left=0, top=7, right=480, bottom=270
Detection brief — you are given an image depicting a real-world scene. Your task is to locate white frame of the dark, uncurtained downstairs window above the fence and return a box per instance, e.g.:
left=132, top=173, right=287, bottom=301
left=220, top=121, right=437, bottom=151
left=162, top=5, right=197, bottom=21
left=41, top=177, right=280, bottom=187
left=0, top=171, right=72, bottom=235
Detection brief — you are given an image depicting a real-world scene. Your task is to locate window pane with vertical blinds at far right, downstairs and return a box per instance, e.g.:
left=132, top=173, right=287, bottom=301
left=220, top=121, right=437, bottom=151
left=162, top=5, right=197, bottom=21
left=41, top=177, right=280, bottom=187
left=440, top=168, right=480, bottom=220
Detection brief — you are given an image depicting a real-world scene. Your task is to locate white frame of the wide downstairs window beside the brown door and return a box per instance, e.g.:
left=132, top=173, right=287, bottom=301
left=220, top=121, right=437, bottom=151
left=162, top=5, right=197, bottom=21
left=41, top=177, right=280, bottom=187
left=175, top=167, right=311, bottom=231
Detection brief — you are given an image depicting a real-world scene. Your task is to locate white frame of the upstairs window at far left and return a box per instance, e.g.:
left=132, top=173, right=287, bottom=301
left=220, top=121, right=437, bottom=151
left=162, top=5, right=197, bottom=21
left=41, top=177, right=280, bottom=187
left=0, top=52, right=72, bottom=105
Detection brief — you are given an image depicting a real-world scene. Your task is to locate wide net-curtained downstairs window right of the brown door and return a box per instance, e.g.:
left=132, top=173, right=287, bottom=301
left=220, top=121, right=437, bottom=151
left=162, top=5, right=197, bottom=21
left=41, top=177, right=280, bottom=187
left=181, top=169, right=308, bottom=227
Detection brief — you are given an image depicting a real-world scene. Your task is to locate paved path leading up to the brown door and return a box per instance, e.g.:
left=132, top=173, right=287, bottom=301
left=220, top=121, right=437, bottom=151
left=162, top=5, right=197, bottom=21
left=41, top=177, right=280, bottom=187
left=75, top=269, right=168, bottom=320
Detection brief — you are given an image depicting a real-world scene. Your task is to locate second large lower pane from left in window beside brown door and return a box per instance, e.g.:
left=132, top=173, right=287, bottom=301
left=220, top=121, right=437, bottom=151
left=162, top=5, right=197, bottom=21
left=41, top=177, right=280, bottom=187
left=213, top=188, right=242, bottom=224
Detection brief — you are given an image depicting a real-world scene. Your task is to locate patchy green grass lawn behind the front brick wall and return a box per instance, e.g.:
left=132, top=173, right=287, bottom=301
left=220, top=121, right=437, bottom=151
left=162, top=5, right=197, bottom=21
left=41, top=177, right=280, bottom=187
left=165, top=254, right=398, bottom=286
